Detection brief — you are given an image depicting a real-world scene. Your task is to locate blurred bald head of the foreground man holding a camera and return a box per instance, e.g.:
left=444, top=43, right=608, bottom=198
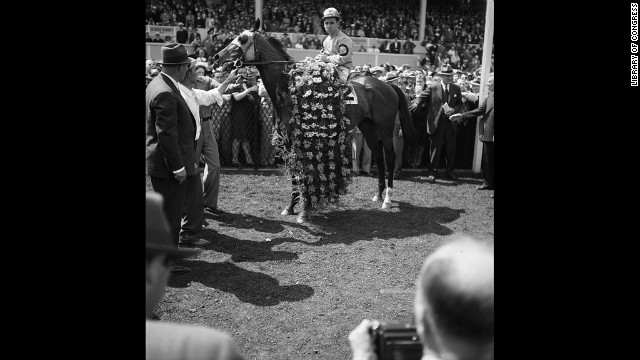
left=415, top=238, right=494, bottom=359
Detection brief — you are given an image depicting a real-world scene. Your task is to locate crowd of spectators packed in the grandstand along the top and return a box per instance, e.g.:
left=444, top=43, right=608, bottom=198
left=146, top=0, right=492, bottom=72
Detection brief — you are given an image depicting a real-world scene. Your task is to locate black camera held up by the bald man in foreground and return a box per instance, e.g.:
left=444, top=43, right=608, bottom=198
left=371, top=322, right=422, bottom=360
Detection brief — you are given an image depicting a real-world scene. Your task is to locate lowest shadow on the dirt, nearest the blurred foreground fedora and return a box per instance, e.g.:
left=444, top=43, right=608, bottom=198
left=168, top=260, right=314, bottom=306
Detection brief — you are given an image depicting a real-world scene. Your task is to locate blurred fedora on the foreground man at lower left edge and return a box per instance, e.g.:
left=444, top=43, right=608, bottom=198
left=146, top=192, right=202, bottom=259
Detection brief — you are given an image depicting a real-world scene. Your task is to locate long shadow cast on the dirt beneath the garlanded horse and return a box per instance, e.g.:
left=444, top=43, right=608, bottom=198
left=202, top=202, right=465, bottom=262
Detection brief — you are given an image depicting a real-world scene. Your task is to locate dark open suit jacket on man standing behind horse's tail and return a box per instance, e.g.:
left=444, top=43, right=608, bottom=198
left=412, top=82, right=462, bottom=135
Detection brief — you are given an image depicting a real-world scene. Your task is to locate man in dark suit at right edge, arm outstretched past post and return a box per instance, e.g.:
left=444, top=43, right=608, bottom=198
left=451, top=73, right=495, bottom=190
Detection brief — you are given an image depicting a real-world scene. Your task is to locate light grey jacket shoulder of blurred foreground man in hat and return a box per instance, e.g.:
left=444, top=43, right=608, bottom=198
left=146, top=320, right=243, bottom=360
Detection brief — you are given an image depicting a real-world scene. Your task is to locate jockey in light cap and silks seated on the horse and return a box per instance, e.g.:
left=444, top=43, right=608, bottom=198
left=315, top=8, right=353, bottom=82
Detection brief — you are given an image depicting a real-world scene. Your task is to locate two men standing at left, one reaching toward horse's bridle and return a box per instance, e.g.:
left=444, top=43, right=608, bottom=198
left=146, top=43, right=238, bottom=272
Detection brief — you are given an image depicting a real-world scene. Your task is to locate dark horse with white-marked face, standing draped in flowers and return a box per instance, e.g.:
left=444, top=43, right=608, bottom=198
left=214, top=19, right=417, bottom=223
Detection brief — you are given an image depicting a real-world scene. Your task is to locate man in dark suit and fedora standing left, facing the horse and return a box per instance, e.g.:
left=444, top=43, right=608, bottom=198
left=146, top=43, right=202, bottom=272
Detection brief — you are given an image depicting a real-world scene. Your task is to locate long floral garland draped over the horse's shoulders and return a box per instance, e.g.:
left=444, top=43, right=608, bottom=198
left=272, top=58, right=351, bottom=206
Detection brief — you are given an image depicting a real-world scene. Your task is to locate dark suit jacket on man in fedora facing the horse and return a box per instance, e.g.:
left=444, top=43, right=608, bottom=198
left=146, top=73, right=197, bottom=179
